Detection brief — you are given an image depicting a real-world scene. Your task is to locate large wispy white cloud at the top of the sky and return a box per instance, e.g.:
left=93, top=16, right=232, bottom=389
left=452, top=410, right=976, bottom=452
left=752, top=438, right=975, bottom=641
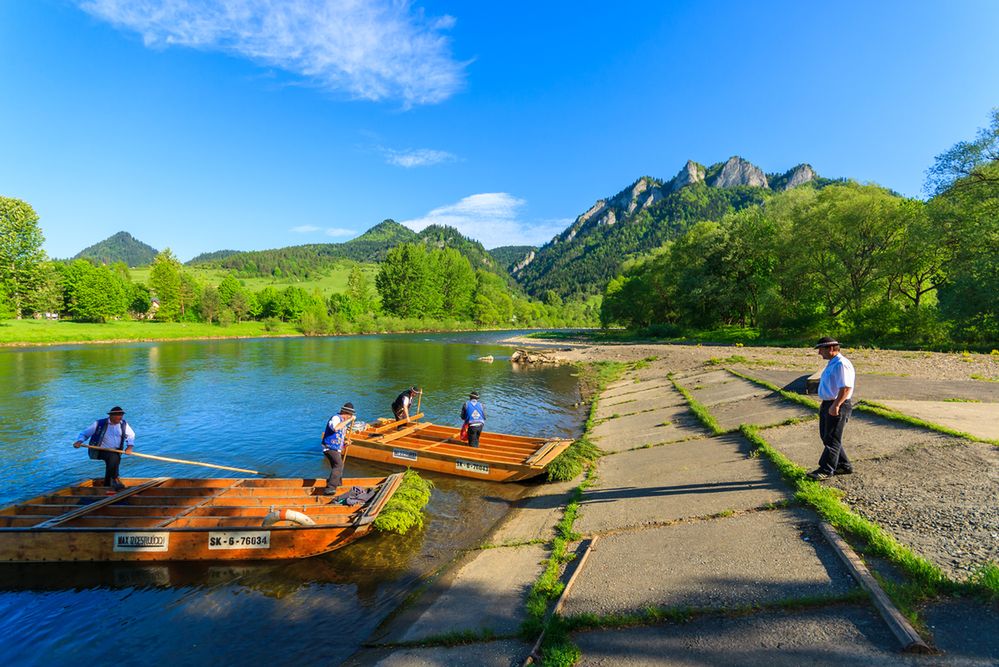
left=77, top=0, right=467, bottom=107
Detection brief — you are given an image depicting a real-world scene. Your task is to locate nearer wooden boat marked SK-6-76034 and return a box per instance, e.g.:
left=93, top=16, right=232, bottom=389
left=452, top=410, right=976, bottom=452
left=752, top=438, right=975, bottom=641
left=0, top=473, right=402, bottom=563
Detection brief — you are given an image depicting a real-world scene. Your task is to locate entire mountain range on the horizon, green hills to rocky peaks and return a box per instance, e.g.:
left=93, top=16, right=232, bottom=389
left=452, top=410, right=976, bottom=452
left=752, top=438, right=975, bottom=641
left=77, top=156, right=835, bottom=298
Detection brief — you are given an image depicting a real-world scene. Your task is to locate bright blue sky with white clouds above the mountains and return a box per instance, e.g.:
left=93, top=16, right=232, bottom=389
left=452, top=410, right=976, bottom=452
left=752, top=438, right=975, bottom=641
left=0, top=0, right=999, bottom=259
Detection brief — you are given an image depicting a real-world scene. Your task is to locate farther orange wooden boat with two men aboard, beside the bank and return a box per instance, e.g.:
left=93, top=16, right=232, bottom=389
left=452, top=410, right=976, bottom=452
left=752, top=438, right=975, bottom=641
left=347, top=413, right=572, bottom=482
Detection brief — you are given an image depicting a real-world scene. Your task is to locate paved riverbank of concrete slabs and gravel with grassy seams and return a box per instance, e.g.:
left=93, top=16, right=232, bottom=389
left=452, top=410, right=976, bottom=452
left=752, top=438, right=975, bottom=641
left=347, top=338, right=999, bottom=667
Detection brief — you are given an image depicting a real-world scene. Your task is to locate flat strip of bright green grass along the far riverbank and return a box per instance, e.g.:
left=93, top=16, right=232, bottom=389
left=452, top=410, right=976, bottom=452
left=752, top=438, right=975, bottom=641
left=0, top=320, right=301, bottom=345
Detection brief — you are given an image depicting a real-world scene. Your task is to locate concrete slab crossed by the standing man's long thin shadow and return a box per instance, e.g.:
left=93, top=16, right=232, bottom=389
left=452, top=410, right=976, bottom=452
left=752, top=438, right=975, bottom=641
left=576, top=436, right=790, bottom=534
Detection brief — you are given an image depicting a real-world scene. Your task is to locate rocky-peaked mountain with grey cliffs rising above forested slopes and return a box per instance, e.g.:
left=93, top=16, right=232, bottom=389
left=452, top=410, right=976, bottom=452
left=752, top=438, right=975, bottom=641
left=511, top=156, right=831, bottom=298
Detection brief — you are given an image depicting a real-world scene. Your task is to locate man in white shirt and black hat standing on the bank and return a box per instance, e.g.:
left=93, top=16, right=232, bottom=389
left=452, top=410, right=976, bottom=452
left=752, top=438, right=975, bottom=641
left=808, top=337, right=857, bottom=481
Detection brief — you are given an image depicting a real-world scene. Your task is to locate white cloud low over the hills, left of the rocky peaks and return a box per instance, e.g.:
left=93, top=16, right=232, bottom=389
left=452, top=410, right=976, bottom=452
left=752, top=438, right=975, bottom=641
left=402, top=192, right=572, bottom=248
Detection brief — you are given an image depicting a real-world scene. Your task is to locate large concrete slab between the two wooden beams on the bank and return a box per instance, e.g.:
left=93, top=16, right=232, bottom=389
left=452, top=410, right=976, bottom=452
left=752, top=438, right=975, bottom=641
left=564, top=509, right=856, bottom=615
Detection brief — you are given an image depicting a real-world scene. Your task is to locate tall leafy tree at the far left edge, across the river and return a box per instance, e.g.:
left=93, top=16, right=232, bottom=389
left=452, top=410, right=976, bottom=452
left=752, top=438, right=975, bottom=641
left=0, top=197, right=45, bottom=319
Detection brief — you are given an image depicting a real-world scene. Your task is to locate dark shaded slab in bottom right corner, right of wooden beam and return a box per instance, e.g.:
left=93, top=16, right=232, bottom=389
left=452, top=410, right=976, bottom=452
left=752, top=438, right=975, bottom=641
left=922, top=600, right=999, bottom=665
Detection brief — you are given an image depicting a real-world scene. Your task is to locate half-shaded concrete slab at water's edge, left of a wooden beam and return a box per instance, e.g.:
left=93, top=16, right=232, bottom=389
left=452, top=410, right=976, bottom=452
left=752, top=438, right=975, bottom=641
left=386, top=544, right=547, bottom=642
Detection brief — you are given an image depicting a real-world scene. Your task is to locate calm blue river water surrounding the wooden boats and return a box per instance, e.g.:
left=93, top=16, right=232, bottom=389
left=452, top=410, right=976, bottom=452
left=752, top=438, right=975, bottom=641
left=0, top=333, right=583, bottom=665
